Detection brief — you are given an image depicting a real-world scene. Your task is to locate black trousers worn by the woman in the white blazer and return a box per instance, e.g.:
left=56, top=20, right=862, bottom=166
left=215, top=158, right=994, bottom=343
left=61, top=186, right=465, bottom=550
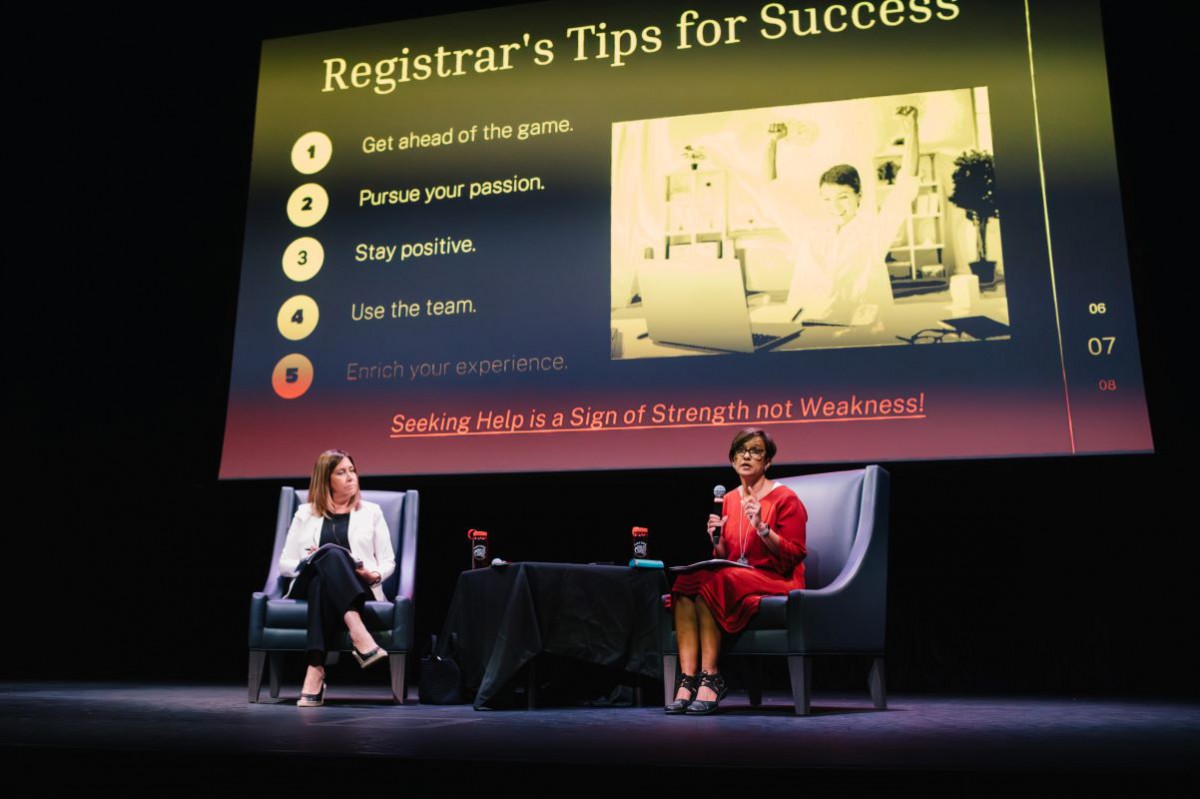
left=292, top=548, right=372, bottom=666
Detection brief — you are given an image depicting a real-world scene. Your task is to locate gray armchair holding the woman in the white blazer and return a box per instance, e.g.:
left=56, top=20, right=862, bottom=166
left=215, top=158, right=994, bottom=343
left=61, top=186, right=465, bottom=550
left=250, top=486, right=418, bottom=703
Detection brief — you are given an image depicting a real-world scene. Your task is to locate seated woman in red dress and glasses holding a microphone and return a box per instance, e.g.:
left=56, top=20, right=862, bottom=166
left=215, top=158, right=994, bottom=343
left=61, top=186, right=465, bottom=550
left=666, top=428, right=809, bottom=715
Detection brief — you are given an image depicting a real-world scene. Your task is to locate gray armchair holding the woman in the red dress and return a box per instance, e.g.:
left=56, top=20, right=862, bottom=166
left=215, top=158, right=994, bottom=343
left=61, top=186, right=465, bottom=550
left=660, top=465, right=888, bottom=715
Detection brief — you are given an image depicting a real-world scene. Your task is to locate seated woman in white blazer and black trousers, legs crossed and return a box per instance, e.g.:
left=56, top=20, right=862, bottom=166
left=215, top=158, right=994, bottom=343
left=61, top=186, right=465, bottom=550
left=280, top=450, right=396, bottom=708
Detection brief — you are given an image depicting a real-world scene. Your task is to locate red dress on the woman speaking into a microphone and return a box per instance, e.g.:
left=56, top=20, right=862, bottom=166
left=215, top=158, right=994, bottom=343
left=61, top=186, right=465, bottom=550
left=671, top=483, right=809, bottom=632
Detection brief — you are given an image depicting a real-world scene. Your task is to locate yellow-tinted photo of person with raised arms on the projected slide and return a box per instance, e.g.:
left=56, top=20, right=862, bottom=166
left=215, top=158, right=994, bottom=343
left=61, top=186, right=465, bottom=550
left=611, top=86, right=1010, bottom=360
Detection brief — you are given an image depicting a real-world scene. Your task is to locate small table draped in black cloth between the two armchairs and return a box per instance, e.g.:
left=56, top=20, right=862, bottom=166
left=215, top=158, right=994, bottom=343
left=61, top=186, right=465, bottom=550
left=438, top=563, right=667, bottom=710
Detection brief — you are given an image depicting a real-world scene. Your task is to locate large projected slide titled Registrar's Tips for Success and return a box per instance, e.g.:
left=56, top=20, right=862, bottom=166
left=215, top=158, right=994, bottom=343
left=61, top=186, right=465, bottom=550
left=221, top=0, right=1153, bottom=477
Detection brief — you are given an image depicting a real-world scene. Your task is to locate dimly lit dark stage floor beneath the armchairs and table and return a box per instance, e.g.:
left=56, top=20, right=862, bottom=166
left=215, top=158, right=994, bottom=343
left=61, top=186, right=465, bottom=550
left=0, top=683, right=1200, bottom=794
